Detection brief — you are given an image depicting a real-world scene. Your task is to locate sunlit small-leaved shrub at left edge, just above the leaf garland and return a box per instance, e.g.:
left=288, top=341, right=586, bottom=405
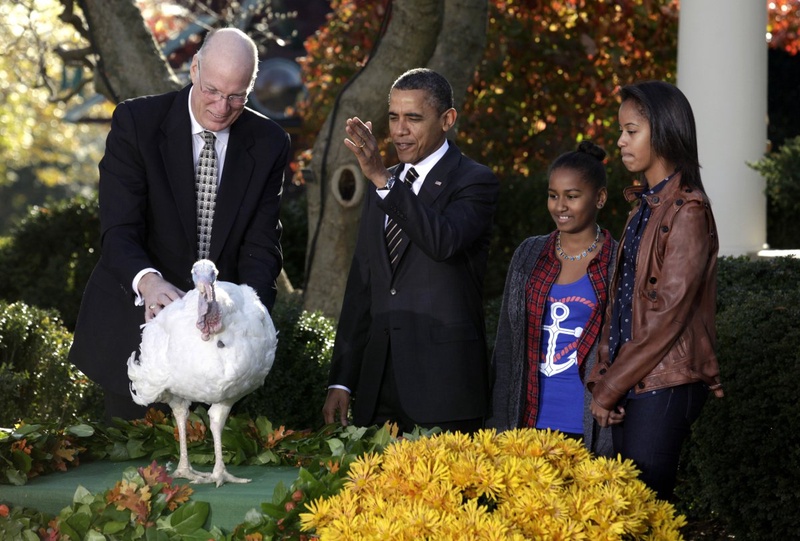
left=0, top=301, right=99, bottom=427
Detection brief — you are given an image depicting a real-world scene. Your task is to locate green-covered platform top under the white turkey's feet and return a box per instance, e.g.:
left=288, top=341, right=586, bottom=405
left=0, top=461, right=298, bottom=532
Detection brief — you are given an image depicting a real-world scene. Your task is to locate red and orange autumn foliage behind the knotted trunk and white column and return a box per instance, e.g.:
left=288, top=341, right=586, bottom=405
left=300, top=0, right=800, bottom=179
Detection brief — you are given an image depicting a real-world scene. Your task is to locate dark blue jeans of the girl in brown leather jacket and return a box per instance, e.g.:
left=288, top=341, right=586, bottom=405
left=612, top=382, right=708, bottom=500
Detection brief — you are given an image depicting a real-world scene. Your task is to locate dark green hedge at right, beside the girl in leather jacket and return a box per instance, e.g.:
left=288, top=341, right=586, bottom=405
left=677, top=258, right=800, bottom=541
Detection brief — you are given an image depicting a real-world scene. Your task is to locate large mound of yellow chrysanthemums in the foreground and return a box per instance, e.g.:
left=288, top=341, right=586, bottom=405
left=300, top=429, right=685, bottom=541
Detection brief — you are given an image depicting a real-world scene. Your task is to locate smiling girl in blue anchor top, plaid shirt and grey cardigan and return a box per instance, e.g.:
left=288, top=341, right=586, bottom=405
left=486, top=141, right=621, bottom=455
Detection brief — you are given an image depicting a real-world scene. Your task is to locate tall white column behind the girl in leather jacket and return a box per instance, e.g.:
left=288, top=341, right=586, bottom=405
left=678, top=0, right=767, bottom=255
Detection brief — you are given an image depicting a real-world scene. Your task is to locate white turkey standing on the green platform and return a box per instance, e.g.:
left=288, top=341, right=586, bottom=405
left=128, top=259, right=278, bottom=486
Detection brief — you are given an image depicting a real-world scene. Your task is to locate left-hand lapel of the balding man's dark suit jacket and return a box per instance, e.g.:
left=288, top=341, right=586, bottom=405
left=159, top=87, right=197, bottom=251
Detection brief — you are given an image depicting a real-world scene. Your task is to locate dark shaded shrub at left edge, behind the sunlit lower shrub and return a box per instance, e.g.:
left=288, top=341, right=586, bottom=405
left=0, top=197, right=100, bottom=330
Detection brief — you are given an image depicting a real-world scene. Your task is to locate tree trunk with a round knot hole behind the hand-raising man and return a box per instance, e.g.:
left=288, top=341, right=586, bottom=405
left=303, top=0, right=488, bottom=317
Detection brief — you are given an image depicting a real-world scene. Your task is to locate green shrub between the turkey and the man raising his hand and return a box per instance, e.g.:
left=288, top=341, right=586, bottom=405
left=235, top=297, right=336, bottom=430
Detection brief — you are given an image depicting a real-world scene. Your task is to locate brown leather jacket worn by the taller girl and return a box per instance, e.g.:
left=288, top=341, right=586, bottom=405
left=588, top=174, right=723, bottom=410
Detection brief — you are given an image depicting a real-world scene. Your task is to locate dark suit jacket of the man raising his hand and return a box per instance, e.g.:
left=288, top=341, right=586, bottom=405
left=329, top=142, right=499, bottom=425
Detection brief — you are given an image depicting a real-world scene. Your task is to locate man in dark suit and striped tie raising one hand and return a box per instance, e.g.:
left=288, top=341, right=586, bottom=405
left=323, top=69, right=499, bottom=432
